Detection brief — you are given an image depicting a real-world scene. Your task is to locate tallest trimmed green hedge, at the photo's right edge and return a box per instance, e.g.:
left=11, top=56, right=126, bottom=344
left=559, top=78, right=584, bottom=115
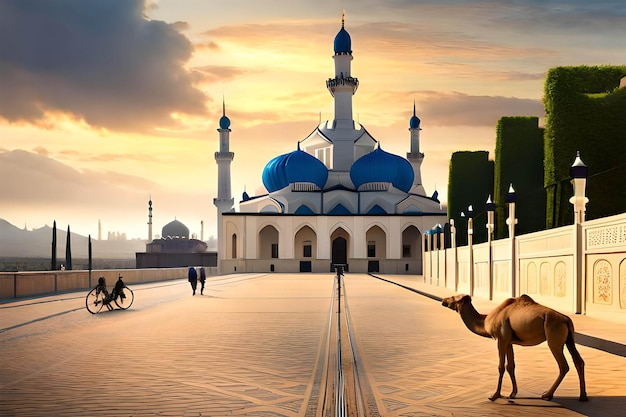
left=544, top=65, right=626, bottom=228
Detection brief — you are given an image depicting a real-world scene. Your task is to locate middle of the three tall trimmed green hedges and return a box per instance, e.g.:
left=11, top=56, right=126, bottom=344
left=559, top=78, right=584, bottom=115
left=493, top=117, right=546, bottom=239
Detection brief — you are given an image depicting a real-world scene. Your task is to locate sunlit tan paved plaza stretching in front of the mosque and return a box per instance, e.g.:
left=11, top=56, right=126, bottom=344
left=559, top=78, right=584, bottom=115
left=0, top=274, right=626, bottom=417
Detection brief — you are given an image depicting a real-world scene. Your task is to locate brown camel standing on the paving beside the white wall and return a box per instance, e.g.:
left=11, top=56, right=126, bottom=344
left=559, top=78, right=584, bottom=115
left=442, top=294, right=587, bottom=401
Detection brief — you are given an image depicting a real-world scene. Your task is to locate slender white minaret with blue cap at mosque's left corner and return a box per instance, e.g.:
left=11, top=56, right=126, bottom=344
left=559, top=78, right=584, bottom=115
left=213, top=101, right=235, bottom=251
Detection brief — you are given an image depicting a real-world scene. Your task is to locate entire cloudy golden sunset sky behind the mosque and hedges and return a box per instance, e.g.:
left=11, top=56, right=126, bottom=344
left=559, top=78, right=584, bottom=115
left=0, top=0, right=626, bottom=240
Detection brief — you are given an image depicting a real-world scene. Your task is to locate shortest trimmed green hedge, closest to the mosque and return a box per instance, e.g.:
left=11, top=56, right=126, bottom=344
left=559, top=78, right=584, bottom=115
left=448, top=151, right=494, bottom=246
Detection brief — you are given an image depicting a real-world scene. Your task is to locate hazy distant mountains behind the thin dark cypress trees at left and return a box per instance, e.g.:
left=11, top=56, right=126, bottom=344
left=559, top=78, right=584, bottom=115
left=0, top=219, right=146, bottom=259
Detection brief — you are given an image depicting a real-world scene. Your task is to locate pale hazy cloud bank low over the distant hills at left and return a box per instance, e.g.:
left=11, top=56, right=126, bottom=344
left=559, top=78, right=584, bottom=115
left=0, top=150, right=215, bottom=237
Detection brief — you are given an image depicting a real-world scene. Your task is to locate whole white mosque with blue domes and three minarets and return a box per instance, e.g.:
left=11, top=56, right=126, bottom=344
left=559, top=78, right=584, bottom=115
left=213, top=18, right=447, bottom=274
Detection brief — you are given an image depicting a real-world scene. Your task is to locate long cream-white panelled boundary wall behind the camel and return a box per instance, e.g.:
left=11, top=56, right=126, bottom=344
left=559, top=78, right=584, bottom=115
left=422, top=213, right=626, bottom=323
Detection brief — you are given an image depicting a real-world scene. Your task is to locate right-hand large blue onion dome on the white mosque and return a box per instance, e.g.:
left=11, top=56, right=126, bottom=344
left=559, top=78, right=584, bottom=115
left=350, top=146, right=415, bottom=192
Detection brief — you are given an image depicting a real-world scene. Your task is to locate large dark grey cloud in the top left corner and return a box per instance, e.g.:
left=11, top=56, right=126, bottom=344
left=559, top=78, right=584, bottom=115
left=0, top=0, right=205, bottom=132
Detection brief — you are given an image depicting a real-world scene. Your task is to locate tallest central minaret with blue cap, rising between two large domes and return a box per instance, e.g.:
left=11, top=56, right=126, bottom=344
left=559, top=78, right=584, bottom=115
left=326, top=14, right=359, bottom=171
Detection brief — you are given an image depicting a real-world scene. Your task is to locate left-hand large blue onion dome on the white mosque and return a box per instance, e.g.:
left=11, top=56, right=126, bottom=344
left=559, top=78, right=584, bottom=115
left=262, top=148, right=328, bottom=193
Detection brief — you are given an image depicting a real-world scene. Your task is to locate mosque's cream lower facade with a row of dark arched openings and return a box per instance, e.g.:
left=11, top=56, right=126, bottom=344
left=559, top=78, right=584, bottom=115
left=218, top=213, right=445, bottom=274
